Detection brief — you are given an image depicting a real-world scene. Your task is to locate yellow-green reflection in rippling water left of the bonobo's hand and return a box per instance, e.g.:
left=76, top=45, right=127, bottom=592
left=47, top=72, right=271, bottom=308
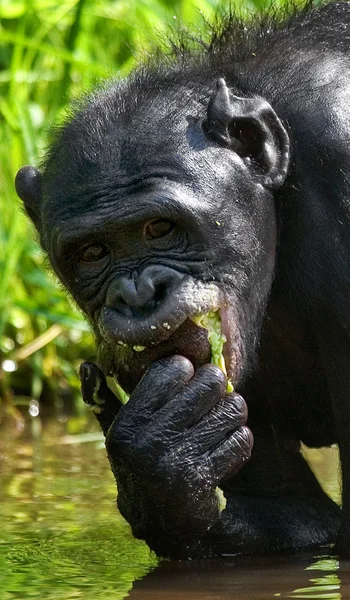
left=0, top=420, right=157, bottom=600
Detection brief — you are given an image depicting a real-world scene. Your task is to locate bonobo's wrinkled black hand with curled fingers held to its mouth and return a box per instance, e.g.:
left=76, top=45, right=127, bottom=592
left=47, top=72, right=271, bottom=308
left=82, top=356, right=252, bottom=554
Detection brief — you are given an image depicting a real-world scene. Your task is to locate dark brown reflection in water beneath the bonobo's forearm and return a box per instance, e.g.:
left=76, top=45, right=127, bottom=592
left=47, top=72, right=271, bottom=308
left=128, top=554, right=344, bottom=600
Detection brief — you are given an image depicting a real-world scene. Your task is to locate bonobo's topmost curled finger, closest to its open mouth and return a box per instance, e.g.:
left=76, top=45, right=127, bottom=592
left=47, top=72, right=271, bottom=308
left=127, top=356, right=194, bottom=414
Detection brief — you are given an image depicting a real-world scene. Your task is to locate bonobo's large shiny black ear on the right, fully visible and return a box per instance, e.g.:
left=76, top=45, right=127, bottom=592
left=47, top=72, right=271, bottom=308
left=203, top=78, right=289, bottom=188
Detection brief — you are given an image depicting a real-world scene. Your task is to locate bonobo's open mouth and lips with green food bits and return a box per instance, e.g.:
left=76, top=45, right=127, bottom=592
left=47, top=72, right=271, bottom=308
left=98, top=277, right=242, bottom=393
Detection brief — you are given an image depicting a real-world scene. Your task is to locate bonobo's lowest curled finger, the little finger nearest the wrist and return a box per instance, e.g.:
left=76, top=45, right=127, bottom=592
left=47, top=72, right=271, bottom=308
left=207, top=426, right=254, bottom=485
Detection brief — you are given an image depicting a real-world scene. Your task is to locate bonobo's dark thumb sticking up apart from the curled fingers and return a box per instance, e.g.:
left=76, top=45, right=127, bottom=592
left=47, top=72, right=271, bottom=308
left=80, top=362, right=121, bottom=435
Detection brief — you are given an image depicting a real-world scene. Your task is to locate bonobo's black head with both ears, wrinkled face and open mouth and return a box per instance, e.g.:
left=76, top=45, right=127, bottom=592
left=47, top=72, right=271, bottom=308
left=16, top=71, right=289, bottom=391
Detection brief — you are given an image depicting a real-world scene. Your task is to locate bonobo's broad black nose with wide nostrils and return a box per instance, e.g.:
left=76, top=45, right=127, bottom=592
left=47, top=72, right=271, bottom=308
left=106, top=265, right=184, bottom=317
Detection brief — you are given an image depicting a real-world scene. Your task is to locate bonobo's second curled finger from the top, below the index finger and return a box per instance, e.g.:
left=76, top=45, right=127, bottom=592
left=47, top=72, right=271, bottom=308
left=159, top=364, right=227, bottom=429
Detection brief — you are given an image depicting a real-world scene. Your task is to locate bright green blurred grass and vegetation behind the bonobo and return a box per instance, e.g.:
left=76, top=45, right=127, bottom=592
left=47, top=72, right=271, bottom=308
left=0, top=0, right=278, bottom=412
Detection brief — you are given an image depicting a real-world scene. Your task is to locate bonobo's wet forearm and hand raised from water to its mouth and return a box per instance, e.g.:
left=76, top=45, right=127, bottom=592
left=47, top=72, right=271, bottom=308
left=81, top=357, right=337, bottom=558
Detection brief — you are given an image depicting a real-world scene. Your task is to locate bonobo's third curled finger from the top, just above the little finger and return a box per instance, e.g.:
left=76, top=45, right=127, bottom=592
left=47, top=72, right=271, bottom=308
left=191, top=393, right=248, bottom=454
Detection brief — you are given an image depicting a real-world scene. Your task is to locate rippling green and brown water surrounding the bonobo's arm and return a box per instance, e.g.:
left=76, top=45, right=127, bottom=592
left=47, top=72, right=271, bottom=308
left=0, top=410, right=350, bottom=600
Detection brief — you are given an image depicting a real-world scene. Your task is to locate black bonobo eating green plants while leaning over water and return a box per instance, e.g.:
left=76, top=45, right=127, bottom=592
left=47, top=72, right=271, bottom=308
left=16, top=3, right=350, bottom=558
